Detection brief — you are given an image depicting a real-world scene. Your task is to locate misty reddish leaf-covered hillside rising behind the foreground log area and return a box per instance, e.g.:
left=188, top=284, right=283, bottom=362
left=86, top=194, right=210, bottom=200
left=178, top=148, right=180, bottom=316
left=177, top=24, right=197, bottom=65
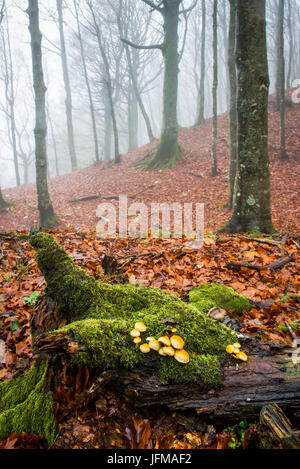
left=0, top=95, right=300, bottom=234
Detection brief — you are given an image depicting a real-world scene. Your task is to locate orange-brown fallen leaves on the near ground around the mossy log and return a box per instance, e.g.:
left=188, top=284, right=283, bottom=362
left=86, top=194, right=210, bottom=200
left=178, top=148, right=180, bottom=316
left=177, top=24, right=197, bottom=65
left=0, top=230, right=300, bottom=449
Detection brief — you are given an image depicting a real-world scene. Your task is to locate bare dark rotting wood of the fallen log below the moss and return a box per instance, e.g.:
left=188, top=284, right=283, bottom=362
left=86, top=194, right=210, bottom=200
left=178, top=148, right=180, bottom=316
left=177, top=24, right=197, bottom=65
left=35, top=322, right=300, bottom=419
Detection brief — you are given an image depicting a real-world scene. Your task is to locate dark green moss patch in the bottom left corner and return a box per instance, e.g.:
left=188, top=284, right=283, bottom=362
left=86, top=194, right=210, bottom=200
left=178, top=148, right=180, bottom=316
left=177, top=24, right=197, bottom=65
left=0, top=362, right=57, bottom=444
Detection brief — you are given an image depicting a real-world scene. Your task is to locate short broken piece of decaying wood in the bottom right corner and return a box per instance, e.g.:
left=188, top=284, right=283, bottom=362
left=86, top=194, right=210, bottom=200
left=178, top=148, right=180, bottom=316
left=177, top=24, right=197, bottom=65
left=260, top=404, right=300, bottom=449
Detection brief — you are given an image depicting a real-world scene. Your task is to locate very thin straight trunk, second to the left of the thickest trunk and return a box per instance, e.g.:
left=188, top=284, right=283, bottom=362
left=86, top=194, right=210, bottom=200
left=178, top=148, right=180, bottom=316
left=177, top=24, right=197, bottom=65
left=211, top=0, right=218, bottom=177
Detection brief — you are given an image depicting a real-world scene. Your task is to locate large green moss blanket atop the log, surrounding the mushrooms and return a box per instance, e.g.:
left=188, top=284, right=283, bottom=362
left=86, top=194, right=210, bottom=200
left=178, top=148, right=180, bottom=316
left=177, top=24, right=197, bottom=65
left=31, top=233, right=240, bottom=384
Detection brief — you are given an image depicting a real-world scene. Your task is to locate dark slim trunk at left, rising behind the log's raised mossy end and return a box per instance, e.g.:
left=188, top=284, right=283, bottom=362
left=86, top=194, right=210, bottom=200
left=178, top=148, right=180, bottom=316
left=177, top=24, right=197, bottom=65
left=27, top=0, right=56, bottom=228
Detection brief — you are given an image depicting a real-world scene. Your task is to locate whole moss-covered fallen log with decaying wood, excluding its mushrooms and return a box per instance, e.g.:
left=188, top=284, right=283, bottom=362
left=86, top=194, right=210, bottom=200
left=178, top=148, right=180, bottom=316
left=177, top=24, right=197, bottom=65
left=0, top=233, right=300, bottom=444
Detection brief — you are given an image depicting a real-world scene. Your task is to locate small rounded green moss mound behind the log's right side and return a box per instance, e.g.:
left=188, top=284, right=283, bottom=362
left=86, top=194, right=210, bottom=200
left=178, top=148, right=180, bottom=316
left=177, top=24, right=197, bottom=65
left=189, top=283, right=251, bottom=313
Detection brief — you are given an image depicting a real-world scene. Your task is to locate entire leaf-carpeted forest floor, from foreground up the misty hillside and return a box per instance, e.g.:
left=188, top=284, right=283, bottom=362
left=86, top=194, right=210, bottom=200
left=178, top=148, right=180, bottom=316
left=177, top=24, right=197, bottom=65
left=0, top=93, right=300, bottom=449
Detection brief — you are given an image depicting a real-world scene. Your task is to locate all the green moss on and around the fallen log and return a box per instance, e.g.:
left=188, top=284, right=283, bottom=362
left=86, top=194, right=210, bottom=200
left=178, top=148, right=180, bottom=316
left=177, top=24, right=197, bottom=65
left=0, top=233, right=243, bottom=444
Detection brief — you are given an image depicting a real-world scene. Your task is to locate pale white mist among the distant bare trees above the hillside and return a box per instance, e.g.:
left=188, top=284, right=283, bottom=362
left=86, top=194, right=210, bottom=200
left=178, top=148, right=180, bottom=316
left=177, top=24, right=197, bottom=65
left=0, top=0, right=300, bottom=188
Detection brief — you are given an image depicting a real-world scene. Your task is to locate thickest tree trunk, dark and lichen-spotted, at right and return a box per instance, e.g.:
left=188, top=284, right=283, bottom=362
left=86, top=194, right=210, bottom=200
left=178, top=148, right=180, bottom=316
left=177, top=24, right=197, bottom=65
left=223, top=0, right=273, bottom=233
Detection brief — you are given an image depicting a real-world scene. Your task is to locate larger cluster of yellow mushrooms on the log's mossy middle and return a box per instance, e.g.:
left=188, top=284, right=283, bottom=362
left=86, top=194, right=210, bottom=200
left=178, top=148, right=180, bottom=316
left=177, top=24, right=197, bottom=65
left=130, top=322, right=190, bottom=363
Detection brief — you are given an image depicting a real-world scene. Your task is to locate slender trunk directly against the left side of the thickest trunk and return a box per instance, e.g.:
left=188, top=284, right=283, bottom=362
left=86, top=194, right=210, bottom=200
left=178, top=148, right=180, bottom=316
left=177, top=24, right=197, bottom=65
left=228, top=0, right=237, bottom=208
